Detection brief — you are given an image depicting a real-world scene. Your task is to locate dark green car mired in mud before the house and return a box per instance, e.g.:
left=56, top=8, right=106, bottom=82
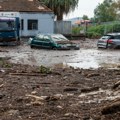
left=28, top=33, right=80, bottom=50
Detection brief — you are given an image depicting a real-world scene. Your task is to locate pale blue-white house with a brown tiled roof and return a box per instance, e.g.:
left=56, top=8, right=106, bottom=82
left=0, top=0, right=54, bottom=36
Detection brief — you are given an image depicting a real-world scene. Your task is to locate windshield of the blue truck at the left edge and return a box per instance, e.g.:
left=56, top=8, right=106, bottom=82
left=0, top=20, right=15, bottom=30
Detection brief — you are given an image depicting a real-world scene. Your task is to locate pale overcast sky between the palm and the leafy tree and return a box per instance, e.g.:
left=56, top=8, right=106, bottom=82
left=64, top=0, right=104, bottom=19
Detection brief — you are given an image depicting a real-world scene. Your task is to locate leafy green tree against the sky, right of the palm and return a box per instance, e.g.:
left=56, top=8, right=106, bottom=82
left=94, top=0, right=116, bottom=22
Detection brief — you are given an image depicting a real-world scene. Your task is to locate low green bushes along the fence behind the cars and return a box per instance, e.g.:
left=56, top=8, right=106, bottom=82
left=72, top=22, right=120, bottom=38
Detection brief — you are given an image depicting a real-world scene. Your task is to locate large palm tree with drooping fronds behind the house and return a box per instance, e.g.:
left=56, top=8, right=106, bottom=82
left=40, top=0, right=79, bottom=20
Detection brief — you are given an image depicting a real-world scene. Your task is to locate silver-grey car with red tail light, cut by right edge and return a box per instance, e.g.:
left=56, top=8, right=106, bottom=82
left=97, top=33, right=120, bottom=48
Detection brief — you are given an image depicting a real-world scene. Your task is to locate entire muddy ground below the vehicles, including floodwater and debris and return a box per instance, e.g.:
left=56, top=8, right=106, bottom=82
left=0, top=40, right=120, bottom=120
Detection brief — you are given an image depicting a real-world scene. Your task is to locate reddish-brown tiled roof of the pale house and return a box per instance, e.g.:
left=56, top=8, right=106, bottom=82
left=0, top=0, right=52, bottom=12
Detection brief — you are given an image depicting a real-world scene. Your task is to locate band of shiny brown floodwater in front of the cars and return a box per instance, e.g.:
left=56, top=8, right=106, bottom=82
left=0, top=44, right=120, bottom=69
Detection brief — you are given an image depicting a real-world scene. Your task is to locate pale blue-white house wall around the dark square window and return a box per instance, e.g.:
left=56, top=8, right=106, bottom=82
left=20, top=12, right=54, bottom=36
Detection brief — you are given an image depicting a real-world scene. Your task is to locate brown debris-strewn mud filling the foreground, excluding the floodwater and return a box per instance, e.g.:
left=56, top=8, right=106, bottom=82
left=0, top=38, right=120, bottom=120
